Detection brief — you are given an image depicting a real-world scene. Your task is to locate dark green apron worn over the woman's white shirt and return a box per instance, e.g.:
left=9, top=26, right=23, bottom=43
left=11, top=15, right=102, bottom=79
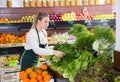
left=21, top=28, right=47, bottom=71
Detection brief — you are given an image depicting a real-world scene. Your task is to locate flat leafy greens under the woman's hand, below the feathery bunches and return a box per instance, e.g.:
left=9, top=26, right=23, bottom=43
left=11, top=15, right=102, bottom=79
left=48, top=42, right=96, bottom=82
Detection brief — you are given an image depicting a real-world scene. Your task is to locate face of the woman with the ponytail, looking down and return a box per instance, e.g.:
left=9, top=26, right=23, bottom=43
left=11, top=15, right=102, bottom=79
left=38, top=17, right=50, bottom=29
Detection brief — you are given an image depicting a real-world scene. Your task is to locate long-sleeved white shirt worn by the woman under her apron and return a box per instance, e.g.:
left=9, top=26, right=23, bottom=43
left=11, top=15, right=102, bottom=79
left=24, top=29, right=53, bottom=55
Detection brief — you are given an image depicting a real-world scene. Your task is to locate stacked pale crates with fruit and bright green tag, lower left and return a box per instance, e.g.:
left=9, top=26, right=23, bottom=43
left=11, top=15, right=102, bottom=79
left=0, top=54, right=20, bottom=82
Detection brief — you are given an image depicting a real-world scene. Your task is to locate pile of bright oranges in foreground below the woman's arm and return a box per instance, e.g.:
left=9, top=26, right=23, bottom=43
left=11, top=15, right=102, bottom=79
left=19, top=64, right=52, bottom=82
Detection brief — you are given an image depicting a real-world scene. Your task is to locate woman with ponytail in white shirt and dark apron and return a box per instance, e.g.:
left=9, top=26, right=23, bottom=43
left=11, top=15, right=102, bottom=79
left=20, top=12, right=64, bottom=71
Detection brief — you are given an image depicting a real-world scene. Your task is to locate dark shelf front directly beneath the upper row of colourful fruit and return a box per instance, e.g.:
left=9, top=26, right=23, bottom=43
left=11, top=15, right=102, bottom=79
left=0, top=19, right=115, bottom=31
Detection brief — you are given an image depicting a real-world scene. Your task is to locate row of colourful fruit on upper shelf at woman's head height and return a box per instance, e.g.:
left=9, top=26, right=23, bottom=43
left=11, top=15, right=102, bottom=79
left=0, top=12, right=116, bottom=23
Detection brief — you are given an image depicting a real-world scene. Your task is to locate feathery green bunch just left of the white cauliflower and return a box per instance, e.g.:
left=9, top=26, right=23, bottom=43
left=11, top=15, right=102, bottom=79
left=68, top=24, right=95, bottom=53
